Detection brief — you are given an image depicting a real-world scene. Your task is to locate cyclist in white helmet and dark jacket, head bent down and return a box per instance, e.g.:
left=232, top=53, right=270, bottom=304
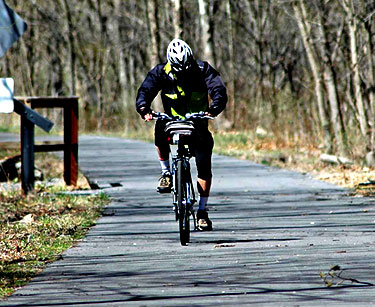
left=136, top=38, right=228, bottom=231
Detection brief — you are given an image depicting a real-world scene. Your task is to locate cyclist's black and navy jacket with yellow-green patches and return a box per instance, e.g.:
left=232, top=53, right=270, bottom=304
left=136, top=61, right=228, bottom=116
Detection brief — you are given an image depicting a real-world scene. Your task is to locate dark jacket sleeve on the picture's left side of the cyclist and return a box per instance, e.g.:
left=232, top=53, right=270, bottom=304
left=135, top=65, right=162, bottom=117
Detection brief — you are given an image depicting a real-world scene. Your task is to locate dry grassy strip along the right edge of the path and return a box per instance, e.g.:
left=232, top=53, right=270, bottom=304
left=214, top=131, right=375, bottom=196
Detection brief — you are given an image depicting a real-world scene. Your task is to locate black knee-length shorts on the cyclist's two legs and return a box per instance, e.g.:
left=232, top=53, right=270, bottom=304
left=155, top=120, right=214, bottom=180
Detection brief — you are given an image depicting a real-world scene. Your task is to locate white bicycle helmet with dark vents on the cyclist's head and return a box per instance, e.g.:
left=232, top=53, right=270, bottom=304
left=167, top=38, right=193, bottom=72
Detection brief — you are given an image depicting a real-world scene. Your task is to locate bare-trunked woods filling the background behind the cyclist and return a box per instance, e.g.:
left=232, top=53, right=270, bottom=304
left=0, top=0, right=375, bottom=161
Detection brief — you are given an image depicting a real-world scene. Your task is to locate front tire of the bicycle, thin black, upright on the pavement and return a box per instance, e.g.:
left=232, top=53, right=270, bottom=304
left=177, top=160, right=190, bottom=245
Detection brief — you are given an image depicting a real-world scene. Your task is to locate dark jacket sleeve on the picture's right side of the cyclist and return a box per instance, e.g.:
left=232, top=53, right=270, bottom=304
left=205, top=62, right=228, bottom=116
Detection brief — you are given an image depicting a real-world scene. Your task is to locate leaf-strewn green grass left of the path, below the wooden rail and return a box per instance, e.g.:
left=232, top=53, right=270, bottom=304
left=0, top=143, right=108, bottom=297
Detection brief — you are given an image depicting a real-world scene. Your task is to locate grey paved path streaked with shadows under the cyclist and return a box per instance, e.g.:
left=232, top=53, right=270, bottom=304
left=0, top=136, right=375, bottom=306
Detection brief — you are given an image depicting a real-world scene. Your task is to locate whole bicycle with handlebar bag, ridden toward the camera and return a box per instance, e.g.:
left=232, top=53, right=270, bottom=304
left=153, top=112, right=213, bottom=246
